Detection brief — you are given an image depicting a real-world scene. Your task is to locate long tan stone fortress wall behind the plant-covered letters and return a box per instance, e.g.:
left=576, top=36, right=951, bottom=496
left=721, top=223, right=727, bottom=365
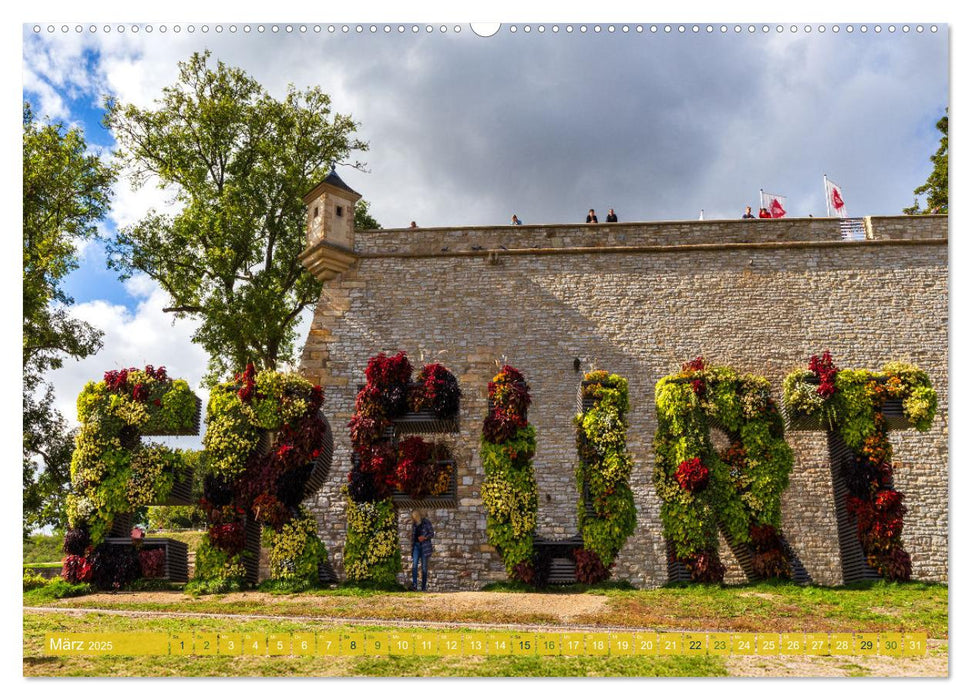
left=300, top=193, right=948, bottom=590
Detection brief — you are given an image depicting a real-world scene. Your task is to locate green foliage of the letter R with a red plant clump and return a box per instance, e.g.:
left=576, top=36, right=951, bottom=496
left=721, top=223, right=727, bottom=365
left=654, top=358, right=793, bottom=580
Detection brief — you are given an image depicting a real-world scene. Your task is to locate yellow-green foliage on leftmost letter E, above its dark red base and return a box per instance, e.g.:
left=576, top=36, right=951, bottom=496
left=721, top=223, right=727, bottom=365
left=67, top=366, right=197, bottom=546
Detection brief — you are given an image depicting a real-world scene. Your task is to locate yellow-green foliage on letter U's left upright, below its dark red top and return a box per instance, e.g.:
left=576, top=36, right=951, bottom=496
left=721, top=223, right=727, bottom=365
left=480, top=425, right=539, bottom=576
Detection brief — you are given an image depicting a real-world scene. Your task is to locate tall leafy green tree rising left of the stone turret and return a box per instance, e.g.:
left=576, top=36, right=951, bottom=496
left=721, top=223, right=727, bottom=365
left=105, top=52, right=367, bottom=382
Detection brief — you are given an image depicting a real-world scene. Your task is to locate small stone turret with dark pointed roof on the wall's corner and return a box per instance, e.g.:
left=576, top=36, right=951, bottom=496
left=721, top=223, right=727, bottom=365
left=300, top=167, right=361, bottom=281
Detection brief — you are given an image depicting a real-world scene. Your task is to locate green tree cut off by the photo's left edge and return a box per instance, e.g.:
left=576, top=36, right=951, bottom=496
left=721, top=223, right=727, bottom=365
left=23, top=102, right=114, bottom=537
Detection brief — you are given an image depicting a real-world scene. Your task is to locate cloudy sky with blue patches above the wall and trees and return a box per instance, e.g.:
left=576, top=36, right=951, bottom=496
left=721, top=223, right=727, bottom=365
left=23, top=23, right=949, bottom=438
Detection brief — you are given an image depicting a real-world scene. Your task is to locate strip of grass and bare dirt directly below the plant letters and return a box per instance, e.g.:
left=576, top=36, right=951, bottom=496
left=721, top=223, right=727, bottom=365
left=24, top=582, right=948, bottom=639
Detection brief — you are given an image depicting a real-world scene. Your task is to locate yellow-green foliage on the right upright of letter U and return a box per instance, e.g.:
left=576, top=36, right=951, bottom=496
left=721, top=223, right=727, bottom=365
left=575, top=371, right=637, bottom=570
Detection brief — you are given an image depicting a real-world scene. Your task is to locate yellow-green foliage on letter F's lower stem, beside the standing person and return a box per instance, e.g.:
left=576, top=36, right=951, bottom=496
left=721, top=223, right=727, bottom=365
left=343, top=486, right=401, bottom=586
